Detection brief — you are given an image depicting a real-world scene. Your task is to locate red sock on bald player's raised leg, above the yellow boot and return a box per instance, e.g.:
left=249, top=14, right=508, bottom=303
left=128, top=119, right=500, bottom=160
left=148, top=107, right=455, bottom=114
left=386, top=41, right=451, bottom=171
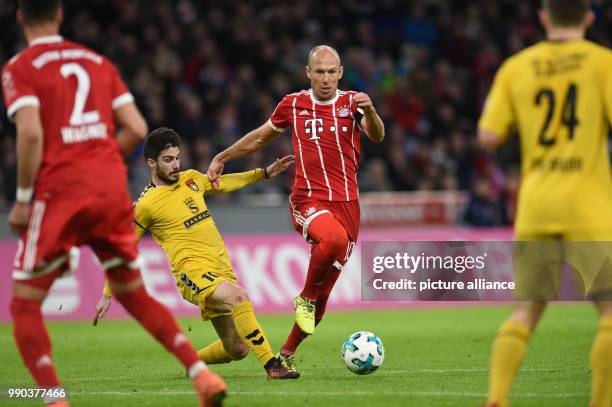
left=300, top=214, right=349, bottom=300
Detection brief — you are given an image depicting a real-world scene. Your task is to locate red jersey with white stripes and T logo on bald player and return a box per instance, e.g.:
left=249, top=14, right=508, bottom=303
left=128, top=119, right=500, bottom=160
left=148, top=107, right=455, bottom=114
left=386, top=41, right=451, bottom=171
left=268, top=90, right=363, bottom=201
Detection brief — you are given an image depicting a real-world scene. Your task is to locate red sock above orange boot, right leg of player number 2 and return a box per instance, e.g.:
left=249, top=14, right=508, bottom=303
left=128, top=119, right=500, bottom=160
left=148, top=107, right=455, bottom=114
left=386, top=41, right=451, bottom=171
left=107, top=267, right=201, bottom=369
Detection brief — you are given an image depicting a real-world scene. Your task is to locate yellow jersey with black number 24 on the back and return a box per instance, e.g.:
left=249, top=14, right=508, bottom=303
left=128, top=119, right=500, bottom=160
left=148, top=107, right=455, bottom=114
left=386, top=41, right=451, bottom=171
left=479, top=40, right=612, bottom=234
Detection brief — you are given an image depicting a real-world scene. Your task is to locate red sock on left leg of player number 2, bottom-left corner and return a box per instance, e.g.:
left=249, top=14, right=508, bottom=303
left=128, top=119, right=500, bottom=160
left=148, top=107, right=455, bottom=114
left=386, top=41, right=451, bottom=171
left=11, top=297, right=60, bottom=387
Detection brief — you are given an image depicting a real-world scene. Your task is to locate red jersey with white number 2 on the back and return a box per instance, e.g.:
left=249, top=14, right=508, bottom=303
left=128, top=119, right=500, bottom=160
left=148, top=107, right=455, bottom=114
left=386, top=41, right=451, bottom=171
left=2, top=36, right=134, bottom=197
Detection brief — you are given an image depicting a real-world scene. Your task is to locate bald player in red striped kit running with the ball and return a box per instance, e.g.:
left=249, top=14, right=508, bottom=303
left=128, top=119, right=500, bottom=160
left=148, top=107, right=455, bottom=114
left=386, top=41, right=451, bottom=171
left=208, top=45, right=385, bottom=369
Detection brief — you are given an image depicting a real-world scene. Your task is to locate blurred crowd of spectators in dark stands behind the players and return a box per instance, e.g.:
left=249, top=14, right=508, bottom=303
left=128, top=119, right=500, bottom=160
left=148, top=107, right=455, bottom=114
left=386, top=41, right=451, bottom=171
left=0, top=0, right=612, bottom=226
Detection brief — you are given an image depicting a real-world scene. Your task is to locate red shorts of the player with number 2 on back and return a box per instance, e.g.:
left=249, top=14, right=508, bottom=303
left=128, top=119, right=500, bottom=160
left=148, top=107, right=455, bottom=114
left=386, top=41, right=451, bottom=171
left=13, top=191, right=138, bottom=280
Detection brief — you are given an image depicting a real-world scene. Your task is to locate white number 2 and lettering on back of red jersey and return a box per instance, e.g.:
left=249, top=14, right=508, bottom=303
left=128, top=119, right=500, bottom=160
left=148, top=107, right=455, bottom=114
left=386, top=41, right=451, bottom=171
left=32, top=49, right=108, bottom=144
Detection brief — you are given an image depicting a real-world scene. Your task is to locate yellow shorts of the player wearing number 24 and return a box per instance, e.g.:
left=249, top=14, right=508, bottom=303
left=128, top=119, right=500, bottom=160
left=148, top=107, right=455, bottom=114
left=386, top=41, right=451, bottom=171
left=514, top=232, right=612, bottom=300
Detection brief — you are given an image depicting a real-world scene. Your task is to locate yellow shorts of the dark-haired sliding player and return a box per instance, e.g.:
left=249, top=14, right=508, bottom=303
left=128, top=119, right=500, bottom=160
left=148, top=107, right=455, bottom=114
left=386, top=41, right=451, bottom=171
left=174, top=270, right=238, bottom=321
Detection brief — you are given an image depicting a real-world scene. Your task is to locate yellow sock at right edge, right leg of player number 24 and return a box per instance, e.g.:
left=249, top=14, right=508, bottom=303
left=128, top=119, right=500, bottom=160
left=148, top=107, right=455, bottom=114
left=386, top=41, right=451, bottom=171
left=589, top=317, right=612, bottom=407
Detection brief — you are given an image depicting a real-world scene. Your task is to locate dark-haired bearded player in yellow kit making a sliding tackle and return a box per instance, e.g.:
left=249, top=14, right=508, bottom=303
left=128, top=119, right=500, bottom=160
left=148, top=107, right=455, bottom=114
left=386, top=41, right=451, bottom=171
left=94, top=127, right=299, bottom=379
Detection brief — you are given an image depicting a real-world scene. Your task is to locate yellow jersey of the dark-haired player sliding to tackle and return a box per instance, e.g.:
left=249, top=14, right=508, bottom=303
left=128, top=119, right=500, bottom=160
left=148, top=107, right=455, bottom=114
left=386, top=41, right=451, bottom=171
left=134, top=169, right=263, bottom=273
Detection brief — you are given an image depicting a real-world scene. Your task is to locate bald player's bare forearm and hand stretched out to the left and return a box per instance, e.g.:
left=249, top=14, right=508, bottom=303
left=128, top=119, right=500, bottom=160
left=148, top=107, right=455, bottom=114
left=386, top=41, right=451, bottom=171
left=206, top=123, right=280, bottom=189
